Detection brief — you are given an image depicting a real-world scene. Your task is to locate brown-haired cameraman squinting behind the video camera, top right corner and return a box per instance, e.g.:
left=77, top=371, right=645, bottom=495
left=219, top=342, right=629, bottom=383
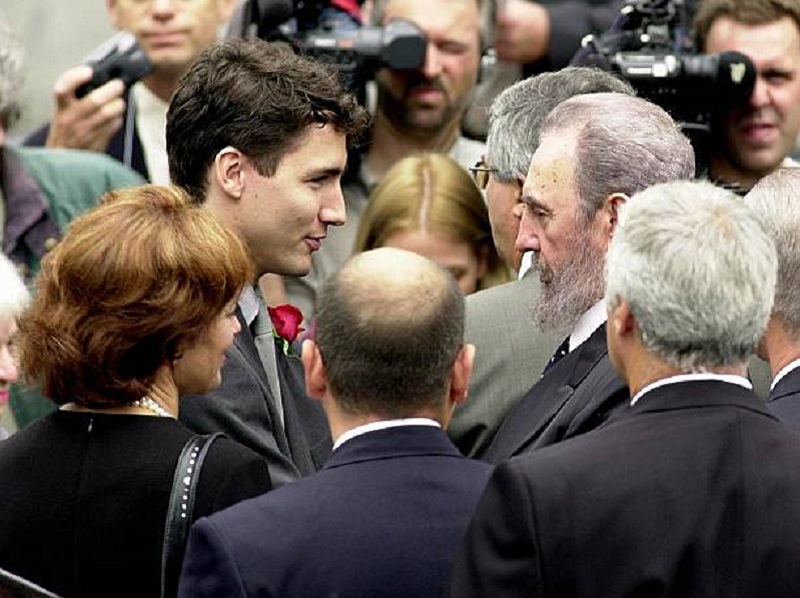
left=694, top=0, right=800, bottom=191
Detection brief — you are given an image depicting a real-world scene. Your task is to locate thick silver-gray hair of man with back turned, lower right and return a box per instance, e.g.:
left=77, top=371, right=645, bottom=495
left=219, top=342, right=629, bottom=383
left=606, top=181, right=777, bottom=371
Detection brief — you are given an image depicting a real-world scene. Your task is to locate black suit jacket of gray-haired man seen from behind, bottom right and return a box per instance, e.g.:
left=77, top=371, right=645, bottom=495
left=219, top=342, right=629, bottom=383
left=452, top=381, right=800, bottom=598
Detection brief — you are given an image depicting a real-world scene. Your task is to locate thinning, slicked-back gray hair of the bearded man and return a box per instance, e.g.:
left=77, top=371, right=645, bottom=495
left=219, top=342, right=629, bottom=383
left=541, top=93, right=695, bottom=220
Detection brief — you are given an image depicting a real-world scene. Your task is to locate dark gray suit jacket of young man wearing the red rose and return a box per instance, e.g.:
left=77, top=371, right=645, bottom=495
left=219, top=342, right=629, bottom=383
left=179, top=309, right=332, bottom=486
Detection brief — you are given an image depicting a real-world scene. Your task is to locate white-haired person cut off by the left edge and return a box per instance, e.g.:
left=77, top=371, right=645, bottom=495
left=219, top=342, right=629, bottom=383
left=0, top=254, right=30, bottom=440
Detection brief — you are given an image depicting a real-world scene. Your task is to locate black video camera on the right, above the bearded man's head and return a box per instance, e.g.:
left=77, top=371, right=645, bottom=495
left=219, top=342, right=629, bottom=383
left=578, top=0, right=756, bottom=170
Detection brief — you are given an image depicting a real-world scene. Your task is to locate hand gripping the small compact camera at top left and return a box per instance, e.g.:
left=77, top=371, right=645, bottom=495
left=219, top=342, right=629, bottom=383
left=46, top=65, right=125, bottom=152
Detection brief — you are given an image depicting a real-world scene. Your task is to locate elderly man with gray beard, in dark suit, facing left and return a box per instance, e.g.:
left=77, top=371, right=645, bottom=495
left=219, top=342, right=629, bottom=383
left=483, top=93, right=695, bottom=463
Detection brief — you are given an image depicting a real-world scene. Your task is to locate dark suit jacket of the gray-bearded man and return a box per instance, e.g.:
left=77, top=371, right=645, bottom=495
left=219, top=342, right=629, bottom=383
left=482, top=324, right=629, bottom=463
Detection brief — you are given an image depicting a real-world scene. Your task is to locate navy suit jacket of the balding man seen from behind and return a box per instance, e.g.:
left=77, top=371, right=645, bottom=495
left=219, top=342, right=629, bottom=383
left=179, top=426, right=490, bottom=598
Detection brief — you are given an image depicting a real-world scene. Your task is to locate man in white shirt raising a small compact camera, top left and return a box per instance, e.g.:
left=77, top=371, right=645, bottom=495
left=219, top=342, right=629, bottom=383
left=25, top=0, right=238, bottom=184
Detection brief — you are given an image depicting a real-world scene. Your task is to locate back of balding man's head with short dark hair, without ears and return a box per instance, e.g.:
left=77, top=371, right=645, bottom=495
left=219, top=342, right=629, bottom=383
left=316, top=248, right=464, bottom=417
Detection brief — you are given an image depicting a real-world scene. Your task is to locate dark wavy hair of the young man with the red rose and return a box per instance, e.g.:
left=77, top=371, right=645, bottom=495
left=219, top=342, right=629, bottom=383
left=167, top=38, right=369, bottom=202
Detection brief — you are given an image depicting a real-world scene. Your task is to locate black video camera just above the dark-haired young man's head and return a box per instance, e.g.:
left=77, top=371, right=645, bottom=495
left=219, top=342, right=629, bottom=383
left=238, top=0, right=427, bottom=96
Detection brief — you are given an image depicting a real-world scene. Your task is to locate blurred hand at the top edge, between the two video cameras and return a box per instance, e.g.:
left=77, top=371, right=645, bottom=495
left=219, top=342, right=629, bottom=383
left=494, top=0, right=550, bottom=64
